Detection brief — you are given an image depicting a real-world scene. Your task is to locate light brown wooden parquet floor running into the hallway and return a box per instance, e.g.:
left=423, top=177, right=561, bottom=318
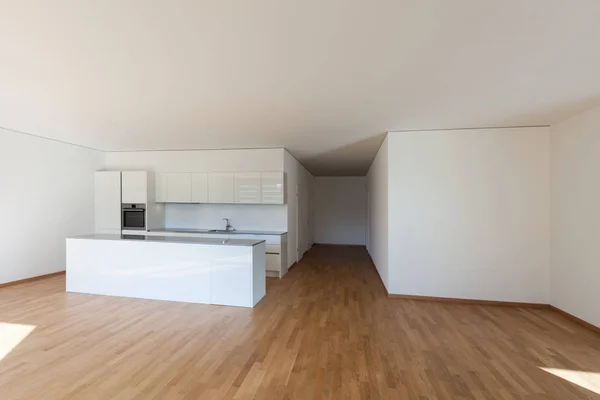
left=0, top=246, right=600, bottom=400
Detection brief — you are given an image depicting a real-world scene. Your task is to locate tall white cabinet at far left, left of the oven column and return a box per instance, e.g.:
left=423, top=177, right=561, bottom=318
left=94, top=171, right=121, bottom=234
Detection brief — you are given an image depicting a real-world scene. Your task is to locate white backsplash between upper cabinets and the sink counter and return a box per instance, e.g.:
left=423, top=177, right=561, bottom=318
left=165, top=204, right=287, bottom=231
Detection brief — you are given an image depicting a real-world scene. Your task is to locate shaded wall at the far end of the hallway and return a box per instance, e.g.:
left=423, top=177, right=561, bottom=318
left=313, top=176, right=367, bottom=245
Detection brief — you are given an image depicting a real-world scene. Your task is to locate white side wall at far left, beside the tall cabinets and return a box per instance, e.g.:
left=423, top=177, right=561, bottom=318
left=0, top=129, right=103, bottom=283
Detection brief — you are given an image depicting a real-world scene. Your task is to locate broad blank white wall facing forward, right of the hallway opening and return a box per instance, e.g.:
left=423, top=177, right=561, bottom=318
left=388, top=128, right=550, bottom=303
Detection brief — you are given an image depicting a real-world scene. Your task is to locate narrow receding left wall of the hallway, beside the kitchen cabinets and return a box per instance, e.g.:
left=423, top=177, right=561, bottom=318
left=283, top=151, right=314, bottom=267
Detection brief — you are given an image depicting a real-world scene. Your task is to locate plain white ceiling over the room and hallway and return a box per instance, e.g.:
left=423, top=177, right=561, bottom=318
left=0, top=0, right=600, bottom=175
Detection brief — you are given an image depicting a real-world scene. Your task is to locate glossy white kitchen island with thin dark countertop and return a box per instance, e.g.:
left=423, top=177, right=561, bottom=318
left=67, top=234, right=266, bottom=307
